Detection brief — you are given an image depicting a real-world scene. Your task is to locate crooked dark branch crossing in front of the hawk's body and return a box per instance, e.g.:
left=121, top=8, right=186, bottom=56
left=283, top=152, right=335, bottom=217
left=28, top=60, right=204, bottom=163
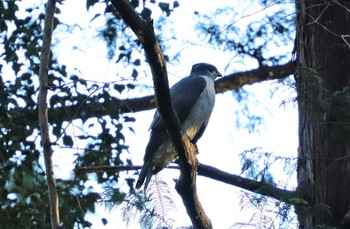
left=111, top=0, right=212, bottom=228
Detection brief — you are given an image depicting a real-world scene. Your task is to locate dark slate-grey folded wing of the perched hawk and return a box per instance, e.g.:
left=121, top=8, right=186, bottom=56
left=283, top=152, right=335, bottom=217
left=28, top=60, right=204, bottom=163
left=150, top=76, right=206, bottom=129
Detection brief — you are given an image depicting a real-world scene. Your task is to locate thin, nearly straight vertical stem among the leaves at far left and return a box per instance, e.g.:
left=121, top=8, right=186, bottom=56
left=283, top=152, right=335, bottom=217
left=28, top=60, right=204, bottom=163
left=38, top=0, right=60, bottom=229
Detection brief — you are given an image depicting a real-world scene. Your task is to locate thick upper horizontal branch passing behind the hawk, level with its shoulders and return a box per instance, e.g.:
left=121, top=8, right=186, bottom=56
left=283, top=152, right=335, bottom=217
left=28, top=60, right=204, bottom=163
left=9, top=62, right=295, bottom=121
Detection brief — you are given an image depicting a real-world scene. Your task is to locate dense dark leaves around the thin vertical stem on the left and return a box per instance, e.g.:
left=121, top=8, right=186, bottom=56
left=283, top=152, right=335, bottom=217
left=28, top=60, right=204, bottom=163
left=0, top=0, right=134, bottom=228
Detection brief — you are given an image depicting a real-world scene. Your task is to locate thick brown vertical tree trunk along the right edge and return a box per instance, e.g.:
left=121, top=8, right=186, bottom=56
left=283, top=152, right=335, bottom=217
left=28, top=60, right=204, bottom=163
left=296, top=0, right=350, bottom=228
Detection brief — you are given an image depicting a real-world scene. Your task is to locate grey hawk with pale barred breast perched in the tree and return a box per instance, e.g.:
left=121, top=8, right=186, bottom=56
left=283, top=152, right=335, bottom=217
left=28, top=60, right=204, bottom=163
left=136, top=63, right=221, bottom=191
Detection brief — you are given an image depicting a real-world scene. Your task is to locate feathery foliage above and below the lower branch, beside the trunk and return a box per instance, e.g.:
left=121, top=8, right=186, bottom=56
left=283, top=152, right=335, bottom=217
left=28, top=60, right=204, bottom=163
left=237, top=147, right=301, bottom=228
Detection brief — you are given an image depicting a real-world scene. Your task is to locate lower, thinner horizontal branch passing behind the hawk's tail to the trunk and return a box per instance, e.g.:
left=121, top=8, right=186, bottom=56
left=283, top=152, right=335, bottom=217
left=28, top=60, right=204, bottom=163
left=74, top=163, right=299, bottom=204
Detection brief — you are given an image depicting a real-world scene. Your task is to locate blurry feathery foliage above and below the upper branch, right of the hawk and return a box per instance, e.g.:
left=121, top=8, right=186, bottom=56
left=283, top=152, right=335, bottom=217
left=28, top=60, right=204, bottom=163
left=196, top=1, right=295, bottom=133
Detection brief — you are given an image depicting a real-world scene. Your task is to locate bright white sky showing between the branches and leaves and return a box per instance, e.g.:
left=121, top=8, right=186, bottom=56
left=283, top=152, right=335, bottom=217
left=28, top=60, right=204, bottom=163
left=47, top=0, right=298, bottom=229
